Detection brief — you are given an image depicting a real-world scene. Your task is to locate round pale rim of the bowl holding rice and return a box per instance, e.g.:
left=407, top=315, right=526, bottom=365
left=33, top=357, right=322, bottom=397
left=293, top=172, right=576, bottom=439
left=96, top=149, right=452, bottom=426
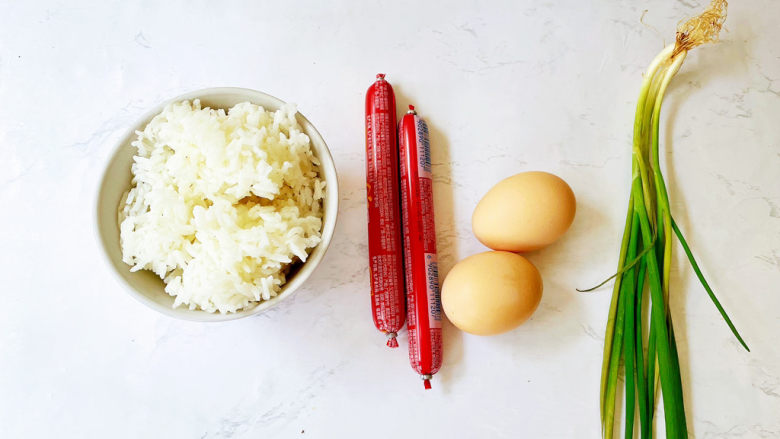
left=92, top=87, right=340, bottom=322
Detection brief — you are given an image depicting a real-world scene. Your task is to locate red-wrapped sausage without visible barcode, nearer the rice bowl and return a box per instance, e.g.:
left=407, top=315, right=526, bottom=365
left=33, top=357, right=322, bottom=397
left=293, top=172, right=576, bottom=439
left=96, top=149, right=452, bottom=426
left=366, top=73, right=406, bottom=348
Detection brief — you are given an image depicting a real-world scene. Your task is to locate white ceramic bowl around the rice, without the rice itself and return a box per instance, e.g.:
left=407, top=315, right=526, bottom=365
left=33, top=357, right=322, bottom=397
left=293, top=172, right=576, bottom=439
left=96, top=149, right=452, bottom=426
left=96, top=88, right=339, bottom=321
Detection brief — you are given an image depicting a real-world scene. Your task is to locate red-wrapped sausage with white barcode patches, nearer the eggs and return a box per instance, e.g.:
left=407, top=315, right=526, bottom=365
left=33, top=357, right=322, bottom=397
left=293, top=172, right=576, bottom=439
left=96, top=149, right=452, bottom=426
left=398, top=105, right=442, bottom=389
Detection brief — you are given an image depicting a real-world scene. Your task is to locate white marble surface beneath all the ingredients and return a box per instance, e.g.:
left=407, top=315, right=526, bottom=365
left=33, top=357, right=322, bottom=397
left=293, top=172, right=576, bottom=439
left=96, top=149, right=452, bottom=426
left=0, top=0, right=780, bottom=438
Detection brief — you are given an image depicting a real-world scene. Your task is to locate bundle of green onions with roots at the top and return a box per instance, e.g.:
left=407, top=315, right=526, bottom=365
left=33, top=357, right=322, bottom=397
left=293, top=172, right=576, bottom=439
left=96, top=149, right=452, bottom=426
left=588, top=0, right=749, bottom=438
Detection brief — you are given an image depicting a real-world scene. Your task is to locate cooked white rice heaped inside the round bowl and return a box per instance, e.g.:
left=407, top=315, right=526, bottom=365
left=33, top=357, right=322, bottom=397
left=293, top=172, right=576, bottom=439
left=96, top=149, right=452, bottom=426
left=119, top=100, right=325, bottom=313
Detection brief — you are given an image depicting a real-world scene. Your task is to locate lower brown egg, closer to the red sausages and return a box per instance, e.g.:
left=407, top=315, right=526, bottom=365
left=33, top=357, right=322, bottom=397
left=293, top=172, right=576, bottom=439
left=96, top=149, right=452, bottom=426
left=441, top=251, right=542, bottom=335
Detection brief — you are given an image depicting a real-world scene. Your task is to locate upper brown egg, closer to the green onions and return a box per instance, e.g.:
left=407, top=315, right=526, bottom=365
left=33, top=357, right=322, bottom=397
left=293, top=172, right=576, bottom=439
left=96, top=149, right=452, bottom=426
left=471, top=172, right=577, bottom=252
